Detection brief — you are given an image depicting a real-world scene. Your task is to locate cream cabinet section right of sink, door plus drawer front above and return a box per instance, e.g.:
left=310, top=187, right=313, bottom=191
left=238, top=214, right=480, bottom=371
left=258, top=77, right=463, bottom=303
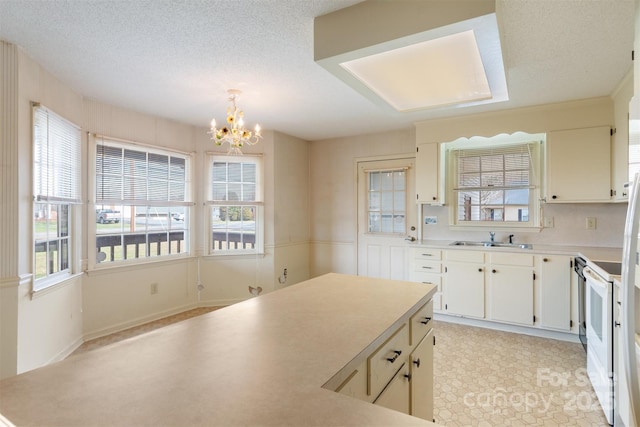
left=487, top=252, right=535, bottom=326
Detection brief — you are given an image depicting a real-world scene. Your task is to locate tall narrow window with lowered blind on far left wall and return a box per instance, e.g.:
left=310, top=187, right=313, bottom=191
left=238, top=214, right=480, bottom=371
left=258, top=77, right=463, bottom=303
left=33, top=104, right=82, bottom=291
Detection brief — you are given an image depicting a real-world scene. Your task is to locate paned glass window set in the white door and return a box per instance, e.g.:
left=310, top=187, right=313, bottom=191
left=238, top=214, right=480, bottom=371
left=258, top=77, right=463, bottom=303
left=367, top=169, right=406, bottom=234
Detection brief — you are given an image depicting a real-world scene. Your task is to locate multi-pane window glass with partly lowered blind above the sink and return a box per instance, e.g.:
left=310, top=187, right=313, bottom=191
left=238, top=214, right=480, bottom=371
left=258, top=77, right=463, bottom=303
left=452, top=143, right=535, bottom=222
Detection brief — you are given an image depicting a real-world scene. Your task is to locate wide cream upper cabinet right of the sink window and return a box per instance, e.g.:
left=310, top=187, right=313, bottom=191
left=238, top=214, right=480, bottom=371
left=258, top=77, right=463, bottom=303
left=545, top=126, right=612, bottom=203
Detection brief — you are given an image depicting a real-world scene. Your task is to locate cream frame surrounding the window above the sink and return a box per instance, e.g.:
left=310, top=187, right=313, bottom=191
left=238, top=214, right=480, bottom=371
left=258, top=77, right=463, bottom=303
left=443, top=132, right=546, bottom=231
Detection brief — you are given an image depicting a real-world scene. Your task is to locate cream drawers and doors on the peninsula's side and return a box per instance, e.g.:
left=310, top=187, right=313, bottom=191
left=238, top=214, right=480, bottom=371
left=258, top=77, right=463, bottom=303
left=336, top=300, right=435, bottom=421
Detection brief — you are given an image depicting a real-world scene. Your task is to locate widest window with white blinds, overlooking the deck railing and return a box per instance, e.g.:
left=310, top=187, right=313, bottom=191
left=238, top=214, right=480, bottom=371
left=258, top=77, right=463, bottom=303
left=92, top=137, right=192, bottom=263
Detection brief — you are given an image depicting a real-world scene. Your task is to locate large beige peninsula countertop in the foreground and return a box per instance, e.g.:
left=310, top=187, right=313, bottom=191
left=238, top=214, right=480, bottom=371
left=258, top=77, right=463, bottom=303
left=0, top=273, right=435, bottom=426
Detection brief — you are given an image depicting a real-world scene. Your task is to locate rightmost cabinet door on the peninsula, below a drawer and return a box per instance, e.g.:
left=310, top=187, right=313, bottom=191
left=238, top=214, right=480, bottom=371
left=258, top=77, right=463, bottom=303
left=409, top=329, right=433, bottom=421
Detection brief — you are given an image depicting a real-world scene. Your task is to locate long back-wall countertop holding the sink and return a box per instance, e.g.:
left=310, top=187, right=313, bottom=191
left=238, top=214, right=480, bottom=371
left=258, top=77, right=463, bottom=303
left=411, top=240, right=622, bottom=262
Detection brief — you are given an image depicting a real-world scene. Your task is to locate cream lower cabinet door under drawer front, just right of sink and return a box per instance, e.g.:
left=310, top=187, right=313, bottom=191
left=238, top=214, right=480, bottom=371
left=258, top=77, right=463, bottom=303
left=487, top=265, right=533, bottom=326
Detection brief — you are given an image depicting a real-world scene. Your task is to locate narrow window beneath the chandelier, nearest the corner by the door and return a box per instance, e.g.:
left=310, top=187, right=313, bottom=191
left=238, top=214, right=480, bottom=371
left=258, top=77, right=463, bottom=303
left=207, top=155, right=264, bottom=255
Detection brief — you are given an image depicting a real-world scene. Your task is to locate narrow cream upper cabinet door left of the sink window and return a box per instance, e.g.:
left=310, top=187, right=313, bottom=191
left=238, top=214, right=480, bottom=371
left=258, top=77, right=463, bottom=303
left=416, top=143, right=444, bottom=204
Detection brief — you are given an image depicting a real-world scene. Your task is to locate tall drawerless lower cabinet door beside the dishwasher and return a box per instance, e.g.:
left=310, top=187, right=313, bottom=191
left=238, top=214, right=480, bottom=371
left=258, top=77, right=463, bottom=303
left=540, top=255, right=571, bottom=331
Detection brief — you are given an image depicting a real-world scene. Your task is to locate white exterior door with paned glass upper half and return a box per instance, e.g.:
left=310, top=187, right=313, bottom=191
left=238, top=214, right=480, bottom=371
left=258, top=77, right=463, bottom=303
left=358, top=158, right=417, bottom=280
